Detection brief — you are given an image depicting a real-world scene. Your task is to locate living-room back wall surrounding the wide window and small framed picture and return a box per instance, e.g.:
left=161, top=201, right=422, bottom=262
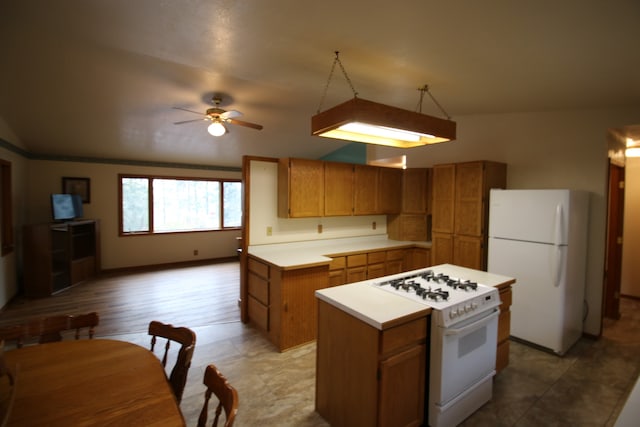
left=28, top=160, right=241, bottom=270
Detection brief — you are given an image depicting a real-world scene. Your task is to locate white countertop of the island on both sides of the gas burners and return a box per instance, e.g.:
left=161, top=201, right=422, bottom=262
left=316, top=264, right=515, bottom=330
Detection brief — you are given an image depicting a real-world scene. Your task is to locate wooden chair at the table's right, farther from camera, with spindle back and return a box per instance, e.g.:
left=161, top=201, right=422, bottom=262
left=149, top=320, right=196, bottom=403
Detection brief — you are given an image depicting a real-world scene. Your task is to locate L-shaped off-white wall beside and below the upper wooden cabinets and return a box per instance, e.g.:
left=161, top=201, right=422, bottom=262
left=248, top=160, right=387, bottom=245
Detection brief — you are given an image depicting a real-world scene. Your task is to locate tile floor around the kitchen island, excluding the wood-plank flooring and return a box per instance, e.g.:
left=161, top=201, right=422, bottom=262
left=106, top=299, right=640, bottom=427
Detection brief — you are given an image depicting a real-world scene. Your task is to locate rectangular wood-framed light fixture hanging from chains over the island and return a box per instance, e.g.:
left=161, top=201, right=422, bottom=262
left=311, top=52, right=456, bottom=148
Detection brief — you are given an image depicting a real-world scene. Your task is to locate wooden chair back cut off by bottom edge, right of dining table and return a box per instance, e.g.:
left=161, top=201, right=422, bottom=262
left=198, top=365, right=238, bottom=427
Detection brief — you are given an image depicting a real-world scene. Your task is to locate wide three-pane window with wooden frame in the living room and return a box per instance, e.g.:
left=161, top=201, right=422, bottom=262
left=119, top=175, right=242, bottom=234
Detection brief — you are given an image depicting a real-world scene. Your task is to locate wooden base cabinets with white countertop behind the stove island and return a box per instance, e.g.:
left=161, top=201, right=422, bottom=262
left=241, top=235, right=431, bottom=351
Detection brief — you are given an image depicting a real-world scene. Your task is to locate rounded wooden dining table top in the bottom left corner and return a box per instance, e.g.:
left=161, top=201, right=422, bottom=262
left=4, top=339, right=186, bottom=427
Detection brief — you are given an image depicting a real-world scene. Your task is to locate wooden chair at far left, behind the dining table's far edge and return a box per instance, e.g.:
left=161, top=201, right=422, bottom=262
left=0, top=312, right=100, bottom=348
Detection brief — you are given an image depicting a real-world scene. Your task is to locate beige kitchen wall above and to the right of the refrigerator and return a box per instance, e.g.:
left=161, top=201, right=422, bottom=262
left=368, top=108, right=640, bottom=335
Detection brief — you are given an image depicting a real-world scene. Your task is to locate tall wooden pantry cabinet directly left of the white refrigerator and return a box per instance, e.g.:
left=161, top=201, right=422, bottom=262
left=432, top=161, right=507, bottom=270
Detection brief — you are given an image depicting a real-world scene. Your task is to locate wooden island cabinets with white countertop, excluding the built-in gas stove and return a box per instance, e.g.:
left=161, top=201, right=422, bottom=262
left=316, top=265, right=515, bottom=426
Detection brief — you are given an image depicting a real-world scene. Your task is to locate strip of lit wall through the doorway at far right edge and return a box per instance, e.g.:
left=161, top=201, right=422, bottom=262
left=620, top=157, right=640, bottom=297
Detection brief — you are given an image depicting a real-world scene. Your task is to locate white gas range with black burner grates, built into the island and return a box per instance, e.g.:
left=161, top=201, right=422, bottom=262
left=371, top=264, right=500, bottom=427
